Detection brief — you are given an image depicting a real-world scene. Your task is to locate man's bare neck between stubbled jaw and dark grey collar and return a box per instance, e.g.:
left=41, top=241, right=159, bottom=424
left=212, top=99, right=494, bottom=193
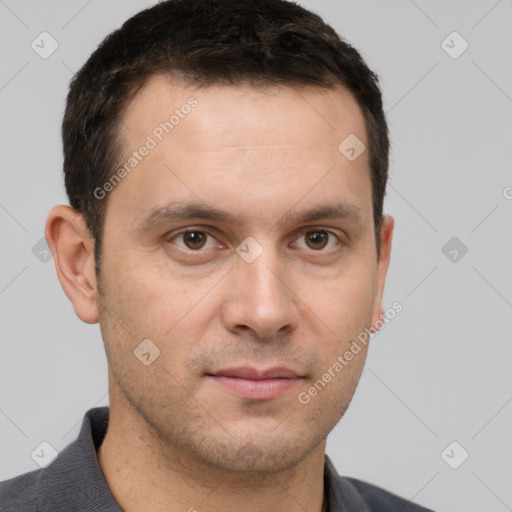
left=98, top=402, right=325, bottom=512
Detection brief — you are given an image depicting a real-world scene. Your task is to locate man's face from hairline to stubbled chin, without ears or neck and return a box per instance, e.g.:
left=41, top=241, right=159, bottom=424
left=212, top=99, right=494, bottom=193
left=98, top=77, right=387, bottom=471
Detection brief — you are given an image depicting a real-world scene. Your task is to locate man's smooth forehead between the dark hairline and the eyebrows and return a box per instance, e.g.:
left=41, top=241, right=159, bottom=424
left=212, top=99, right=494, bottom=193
left=109, top=76, right=371, bottom=226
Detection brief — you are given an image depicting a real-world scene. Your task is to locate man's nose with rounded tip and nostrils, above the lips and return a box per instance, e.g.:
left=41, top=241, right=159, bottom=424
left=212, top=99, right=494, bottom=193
left=221, top=243, right=300, bottom=339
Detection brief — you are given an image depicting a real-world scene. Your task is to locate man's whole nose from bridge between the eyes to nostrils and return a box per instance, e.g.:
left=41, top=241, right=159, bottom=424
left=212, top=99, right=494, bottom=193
left=224, top=239, right=298, bottom=337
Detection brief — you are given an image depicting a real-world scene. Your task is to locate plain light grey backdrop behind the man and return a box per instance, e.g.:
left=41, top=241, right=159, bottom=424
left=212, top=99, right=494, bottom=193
left=0, top=0, right=512, bottom=512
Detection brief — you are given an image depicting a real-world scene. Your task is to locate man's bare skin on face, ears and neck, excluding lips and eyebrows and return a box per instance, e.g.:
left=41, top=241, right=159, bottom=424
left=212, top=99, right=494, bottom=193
left=46, top=76, right=393, bottom=512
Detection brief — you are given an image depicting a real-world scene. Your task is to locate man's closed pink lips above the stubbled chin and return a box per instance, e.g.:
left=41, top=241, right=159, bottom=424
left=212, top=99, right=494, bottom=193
left=206, top=366, right=305, bottom=401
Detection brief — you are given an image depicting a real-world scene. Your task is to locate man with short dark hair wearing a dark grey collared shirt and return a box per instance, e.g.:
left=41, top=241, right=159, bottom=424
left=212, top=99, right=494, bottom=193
left=0, top=0, right=434, bottom=512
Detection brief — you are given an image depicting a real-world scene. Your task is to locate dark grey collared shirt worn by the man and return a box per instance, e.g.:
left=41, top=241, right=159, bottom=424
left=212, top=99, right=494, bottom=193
left=0, top=407, right=432, bottom=512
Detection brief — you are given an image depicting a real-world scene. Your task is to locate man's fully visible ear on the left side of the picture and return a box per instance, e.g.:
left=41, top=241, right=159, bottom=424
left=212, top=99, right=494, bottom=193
left=45, top=205, right=99, bottom=324
